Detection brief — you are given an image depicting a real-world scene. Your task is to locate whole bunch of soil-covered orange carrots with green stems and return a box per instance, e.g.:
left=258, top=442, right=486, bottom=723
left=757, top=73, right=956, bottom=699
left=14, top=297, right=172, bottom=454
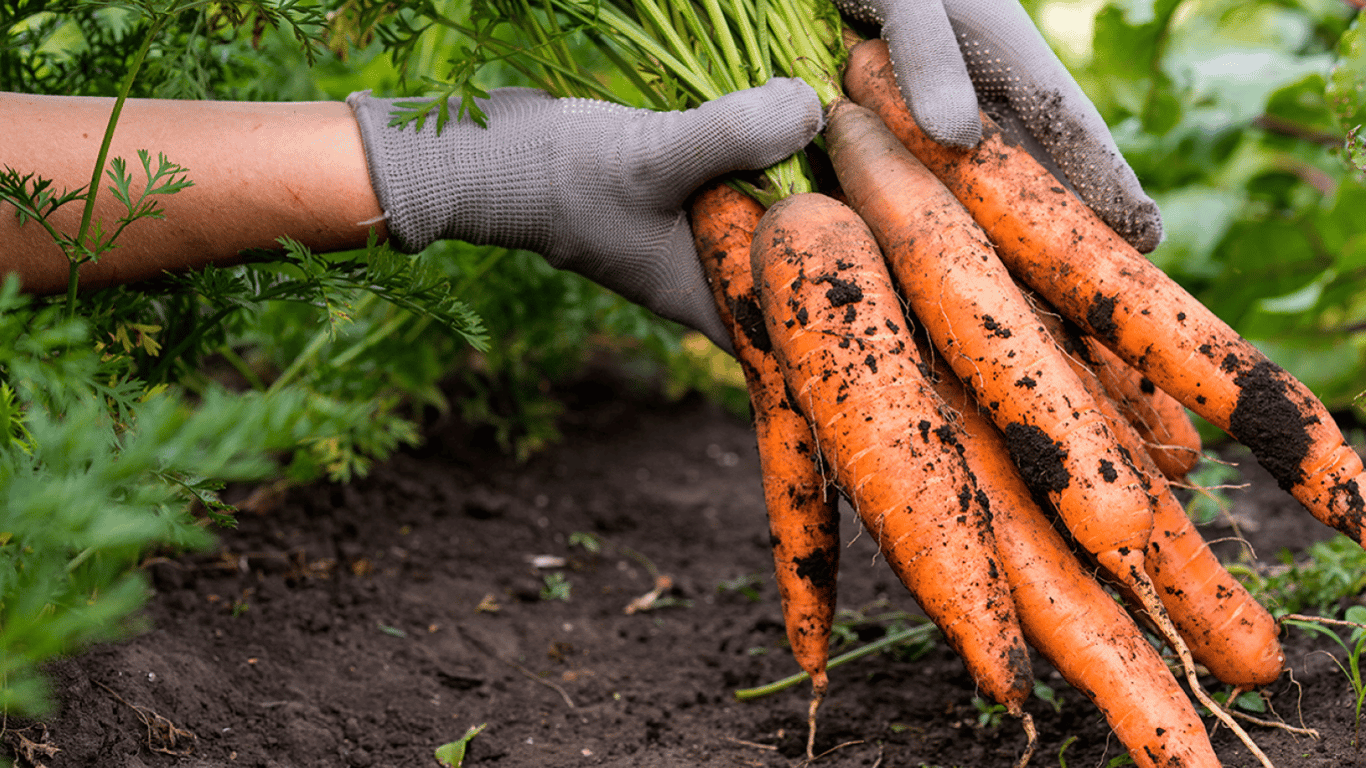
left=499, top=0, right=1366, bottom=768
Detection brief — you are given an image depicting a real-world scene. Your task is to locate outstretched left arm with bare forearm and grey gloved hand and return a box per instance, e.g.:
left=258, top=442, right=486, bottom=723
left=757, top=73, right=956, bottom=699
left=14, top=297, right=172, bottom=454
left=0, top=79, right=821, bottom=347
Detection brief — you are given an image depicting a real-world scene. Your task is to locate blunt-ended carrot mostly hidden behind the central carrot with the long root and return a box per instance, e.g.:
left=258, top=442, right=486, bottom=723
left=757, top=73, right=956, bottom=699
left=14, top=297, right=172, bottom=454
left=1040, top=302, right=1285, bottom=687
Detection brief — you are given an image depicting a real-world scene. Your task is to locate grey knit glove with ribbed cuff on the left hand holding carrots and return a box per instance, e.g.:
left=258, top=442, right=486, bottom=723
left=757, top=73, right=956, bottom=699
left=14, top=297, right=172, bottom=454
left=347, top=78, right=822, bottom=350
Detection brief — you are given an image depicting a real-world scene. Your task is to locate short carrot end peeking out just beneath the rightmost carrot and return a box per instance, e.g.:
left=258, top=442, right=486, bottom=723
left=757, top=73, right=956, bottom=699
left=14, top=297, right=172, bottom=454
left=1085, top=338, right=1201, bottom=480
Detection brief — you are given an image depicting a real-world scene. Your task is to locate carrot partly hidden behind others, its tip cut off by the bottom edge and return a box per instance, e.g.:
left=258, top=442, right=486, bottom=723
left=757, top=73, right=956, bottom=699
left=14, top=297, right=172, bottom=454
left=934, top=344, right=1218, bottom=768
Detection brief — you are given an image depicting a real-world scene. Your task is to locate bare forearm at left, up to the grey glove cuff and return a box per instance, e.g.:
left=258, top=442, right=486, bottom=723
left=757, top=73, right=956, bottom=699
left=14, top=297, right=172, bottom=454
left=0, top=93, right=385, bottom=292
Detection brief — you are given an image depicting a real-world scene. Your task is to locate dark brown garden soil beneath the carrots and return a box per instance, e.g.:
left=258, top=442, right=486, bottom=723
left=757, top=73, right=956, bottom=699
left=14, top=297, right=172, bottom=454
left=7, top=368, right=1359, bottom=768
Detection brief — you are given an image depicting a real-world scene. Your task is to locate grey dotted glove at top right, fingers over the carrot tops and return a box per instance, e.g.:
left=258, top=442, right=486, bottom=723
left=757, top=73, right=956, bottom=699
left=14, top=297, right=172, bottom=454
left=836, top=0, right=1162, bottom=253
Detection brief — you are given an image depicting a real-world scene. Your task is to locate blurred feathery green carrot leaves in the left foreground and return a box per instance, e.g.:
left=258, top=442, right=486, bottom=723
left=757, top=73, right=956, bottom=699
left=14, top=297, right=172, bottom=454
left=0, top=277, right=309, bottom=713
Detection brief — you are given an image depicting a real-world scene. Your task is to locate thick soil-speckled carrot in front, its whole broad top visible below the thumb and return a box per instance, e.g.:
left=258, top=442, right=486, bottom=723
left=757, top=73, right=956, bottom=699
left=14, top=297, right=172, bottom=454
left=751, top=194, right=1031, bottom=715
